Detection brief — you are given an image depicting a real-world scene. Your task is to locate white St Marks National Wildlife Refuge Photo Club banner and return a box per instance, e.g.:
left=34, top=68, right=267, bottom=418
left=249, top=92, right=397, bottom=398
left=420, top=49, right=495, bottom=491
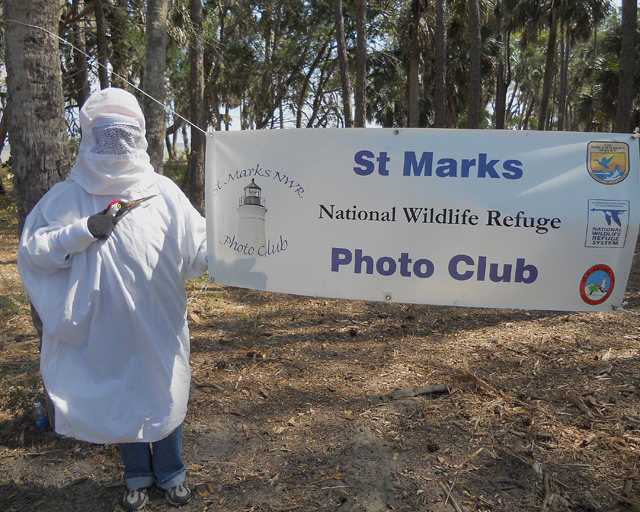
left=206, top=129, right=640, bottom=311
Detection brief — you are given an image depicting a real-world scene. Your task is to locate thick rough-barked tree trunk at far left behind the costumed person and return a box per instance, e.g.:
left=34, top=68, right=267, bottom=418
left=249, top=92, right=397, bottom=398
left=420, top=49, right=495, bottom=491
left=4, top=0, right=70, bottom=232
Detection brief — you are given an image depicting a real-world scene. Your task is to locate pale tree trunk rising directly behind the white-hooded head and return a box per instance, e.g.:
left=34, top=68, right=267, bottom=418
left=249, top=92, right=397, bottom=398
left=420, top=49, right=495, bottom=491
left=142, top=0, right=169, bottom=174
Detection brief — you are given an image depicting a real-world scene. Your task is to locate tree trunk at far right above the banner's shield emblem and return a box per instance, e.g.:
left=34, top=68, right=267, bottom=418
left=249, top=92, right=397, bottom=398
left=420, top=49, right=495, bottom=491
left=614, top=0, right=638, bottom=133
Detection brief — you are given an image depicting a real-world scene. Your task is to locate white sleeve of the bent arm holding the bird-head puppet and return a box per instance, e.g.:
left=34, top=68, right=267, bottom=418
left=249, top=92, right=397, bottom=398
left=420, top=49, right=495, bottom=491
left=21, top=217, right=97, bottom=272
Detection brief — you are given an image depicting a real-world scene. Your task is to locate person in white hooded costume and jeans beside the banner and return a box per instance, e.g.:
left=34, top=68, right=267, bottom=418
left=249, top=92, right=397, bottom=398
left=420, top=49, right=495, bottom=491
left=18, top=88, right=207, bottom=510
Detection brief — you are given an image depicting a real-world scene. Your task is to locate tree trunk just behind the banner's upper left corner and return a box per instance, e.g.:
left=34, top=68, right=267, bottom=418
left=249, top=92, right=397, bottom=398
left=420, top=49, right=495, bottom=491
left=189, top=0, right=206, bottom=214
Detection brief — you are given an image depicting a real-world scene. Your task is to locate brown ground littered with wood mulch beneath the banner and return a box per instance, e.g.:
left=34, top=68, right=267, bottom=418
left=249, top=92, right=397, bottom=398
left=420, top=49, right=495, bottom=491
left=0, top=179, right=640, bottom=512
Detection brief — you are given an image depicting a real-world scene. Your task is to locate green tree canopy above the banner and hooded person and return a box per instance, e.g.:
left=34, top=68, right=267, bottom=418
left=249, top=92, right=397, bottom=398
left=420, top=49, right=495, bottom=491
left=0, top=0, right=640, bottom=163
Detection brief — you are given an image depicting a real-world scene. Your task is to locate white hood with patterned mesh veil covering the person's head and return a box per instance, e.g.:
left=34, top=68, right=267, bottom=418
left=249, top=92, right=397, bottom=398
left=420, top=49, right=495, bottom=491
left=67, top=88, right=158, bottom=199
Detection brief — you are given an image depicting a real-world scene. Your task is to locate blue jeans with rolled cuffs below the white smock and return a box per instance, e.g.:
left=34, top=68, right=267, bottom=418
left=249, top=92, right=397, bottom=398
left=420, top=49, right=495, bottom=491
left=118, top=425, right=185, bottom=489
